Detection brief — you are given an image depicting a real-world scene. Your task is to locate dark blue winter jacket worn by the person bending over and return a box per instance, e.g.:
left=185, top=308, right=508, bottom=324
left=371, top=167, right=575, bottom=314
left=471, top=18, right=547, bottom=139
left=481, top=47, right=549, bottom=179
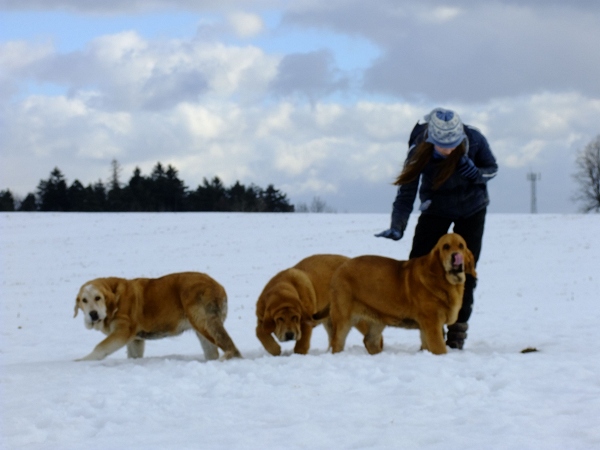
left=392, top=124, right=498, bottom=232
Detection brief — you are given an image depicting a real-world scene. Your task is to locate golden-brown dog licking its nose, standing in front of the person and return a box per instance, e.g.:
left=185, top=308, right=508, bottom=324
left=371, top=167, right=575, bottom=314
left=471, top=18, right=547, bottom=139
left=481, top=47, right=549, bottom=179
left=328, top=234, right=476, bottom=355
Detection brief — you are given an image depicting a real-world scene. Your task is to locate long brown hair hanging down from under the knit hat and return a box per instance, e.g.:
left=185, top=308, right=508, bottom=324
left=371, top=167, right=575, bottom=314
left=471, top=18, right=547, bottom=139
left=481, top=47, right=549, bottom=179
left=394, top=141, right=465, bottom=190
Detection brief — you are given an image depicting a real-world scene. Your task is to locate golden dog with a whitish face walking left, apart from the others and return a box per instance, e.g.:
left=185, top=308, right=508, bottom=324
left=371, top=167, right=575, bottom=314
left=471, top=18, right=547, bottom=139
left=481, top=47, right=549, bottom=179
left=73, top=272, right=241, bottom=361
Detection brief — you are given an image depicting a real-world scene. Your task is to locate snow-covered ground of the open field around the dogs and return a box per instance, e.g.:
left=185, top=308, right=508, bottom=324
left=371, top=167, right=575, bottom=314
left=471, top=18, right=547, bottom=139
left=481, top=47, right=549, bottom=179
left=0, top=213, right=600, bottom=450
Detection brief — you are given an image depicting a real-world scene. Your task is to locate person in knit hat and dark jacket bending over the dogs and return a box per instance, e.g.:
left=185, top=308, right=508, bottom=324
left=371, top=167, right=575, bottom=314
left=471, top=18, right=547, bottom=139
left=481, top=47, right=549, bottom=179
left=375, top=108, right=498, bottom=349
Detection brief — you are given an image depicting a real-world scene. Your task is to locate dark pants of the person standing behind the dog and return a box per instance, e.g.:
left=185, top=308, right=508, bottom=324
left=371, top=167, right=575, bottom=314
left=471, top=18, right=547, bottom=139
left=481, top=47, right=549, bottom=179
left=410, top=208, right=487, bottom=322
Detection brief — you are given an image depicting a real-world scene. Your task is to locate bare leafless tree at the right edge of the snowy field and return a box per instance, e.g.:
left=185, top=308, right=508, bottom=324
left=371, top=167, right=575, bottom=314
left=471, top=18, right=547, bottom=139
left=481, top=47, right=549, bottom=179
left=573, top=134, right=600, bottom=213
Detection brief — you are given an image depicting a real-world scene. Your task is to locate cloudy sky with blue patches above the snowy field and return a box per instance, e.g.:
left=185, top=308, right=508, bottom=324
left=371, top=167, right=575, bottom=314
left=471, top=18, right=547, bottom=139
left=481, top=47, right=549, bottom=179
left=0, top=0, right=600, bottom=213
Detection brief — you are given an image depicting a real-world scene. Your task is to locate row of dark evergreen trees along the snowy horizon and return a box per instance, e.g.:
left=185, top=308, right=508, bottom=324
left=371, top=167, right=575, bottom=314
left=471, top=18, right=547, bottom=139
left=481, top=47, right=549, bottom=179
left=0, top=161, right=294, bottom=212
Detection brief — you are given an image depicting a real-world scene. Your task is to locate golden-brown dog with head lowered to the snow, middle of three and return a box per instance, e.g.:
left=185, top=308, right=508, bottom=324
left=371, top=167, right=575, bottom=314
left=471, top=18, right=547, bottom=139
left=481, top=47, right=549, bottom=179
left=256, top=255, right=378, bottom=356
